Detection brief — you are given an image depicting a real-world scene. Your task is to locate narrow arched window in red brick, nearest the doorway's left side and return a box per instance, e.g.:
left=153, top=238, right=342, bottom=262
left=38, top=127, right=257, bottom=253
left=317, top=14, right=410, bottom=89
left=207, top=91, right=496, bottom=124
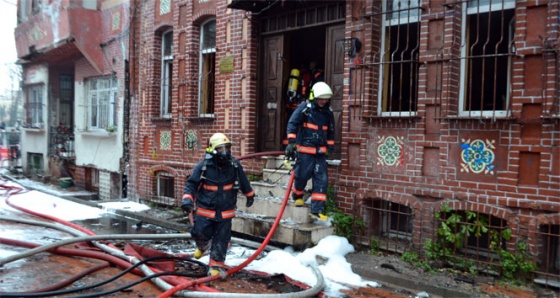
left=198, top=18, right=216, bottom=118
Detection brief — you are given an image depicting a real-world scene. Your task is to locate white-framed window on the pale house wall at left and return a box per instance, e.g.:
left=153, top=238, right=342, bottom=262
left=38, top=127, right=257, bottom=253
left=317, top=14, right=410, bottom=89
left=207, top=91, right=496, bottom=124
left=86, top=76, right=119, bottom=130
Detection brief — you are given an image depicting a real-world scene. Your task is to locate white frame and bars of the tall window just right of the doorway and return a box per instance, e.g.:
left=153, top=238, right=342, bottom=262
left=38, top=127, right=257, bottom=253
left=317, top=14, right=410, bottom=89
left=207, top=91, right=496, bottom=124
left=378, top=0, right=421, bottom=117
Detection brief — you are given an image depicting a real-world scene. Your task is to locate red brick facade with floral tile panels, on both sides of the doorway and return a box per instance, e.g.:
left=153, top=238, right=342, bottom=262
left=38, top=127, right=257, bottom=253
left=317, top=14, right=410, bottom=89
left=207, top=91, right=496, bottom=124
left=130, top=0, right=560, bottom=268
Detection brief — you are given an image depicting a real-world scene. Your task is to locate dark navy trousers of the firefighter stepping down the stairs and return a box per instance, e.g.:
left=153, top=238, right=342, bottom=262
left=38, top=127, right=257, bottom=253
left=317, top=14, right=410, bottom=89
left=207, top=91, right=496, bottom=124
left=293, top=152, right=329, bottom=213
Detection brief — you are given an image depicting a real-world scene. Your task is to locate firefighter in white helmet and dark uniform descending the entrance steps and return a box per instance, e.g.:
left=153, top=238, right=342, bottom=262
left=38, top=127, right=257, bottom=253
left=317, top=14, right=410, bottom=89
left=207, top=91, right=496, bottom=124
left=286, top=82, right=335, bottom=220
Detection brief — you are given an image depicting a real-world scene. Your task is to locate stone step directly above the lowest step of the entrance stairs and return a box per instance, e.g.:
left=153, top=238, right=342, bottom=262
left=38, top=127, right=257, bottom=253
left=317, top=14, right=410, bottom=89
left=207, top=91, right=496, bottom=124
left=237, top=196, right=309, bottom=223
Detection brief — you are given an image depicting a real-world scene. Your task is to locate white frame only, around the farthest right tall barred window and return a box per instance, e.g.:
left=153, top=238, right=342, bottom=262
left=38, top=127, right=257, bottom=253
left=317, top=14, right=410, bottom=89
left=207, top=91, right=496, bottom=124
left=458, top=0, right=515, bottom=118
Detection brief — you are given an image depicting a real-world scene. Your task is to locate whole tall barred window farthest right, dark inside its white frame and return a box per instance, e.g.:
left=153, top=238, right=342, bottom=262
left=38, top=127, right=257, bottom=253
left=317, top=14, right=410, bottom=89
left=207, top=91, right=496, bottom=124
left=459, top=0, right=515, bottom=117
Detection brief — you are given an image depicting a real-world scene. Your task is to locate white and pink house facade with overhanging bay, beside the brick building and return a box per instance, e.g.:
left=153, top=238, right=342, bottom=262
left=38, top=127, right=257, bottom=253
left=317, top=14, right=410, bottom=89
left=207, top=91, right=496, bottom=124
left=15, top=0, right=131, bottom=199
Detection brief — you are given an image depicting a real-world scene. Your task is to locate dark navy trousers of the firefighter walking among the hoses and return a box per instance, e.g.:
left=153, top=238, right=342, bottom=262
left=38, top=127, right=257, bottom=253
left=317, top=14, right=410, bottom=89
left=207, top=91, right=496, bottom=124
left=191, top=215, right=231, bottom=264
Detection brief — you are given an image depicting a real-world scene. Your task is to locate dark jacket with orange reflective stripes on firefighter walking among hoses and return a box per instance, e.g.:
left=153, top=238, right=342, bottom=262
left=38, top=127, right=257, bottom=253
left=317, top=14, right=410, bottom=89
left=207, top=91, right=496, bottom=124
left=183, top=154, right=254, bottom=220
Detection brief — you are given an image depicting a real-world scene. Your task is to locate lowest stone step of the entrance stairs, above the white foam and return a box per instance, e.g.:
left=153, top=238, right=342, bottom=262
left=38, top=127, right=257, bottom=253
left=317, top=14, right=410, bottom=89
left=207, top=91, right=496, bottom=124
left=232, top=213, right=334, bottom=249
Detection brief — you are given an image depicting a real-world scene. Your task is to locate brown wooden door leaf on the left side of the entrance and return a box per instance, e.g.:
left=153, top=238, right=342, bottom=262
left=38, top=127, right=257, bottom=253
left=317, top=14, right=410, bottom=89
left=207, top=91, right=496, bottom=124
left=256, top=35, right=285, bottom=152
